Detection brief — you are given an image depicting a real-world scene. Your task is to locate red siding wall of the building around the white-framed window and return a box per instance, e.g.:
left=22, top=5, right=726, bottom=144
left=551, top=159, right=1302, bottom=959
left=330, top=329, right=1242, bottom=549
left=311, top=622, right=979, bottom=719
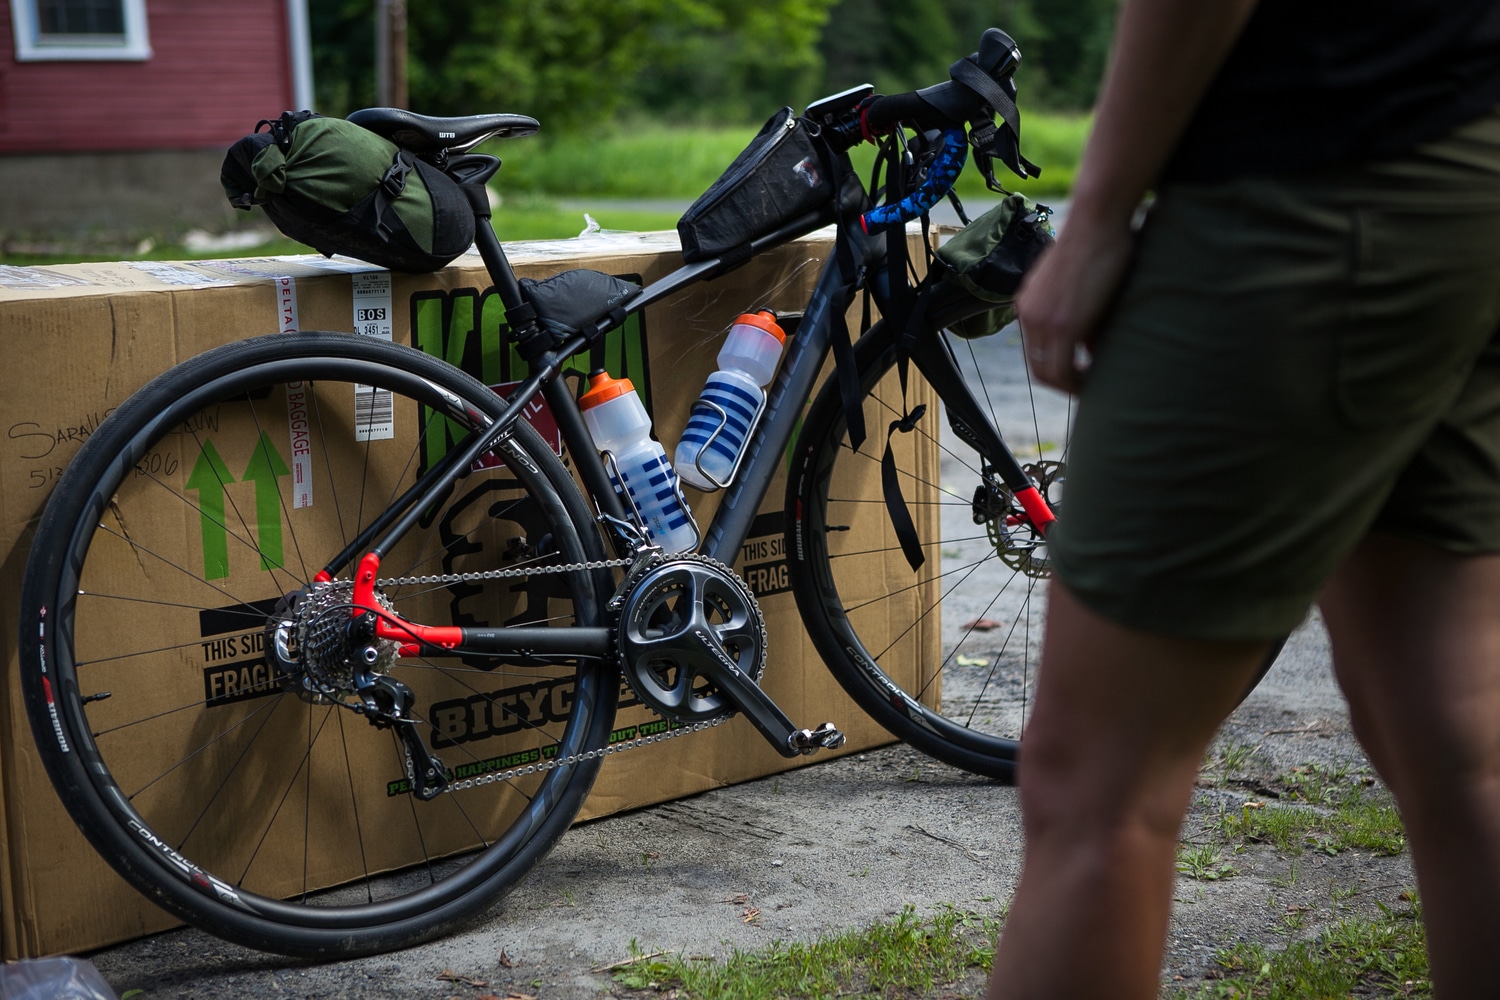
left=0, top=0, right=293, bottom=153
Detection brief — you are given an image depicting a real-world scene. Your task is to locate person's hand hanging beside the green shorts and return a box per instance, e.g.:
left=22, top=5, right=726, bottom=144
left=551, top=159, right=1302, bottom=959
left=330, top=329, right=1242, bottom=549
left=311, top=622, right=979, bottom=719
left=1016, top=217, right=1134, bottom=393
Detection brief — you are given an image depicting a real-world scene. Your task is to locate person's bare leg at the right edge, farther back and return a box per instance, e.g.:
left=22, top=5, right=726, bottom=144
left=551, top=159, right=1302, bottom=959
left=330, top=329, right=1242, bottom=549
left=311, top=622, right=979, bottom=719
left=1320, top=535, right=1500, bottom=1000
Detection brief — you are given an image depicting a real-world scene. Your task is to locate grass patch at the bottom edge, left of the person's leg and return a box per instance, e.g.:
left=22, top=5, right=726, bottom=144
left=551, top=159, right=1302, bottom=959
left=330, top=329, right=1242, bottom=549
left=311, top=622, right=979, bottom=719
left=615, top=907, right=1001, bottom=1000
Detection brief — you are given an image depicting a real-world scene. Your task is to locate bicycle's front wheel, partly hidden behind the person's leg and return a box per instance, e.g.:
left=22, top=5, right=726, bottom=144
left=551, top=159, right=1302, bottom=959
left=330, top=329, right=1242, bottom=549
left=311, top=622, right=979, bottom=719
left=788, top=325, right=1073, bottom=781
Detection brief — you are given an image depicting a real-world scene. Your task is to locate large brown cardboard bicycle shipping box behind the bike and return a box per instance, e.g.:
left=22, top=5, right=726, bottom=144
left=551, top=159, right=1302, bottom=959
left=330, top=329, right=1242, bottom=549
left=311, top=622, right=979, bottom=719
left=0, top=232, right=939, bottom=958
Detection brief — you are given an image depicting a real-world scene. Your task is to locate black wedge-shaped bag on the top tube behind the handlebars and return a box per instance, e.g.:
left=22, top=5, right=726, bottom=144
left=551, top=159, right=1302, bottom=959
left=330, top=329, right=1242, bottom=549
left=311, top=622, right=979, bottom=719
left=677, top=108, right=834, bottom=264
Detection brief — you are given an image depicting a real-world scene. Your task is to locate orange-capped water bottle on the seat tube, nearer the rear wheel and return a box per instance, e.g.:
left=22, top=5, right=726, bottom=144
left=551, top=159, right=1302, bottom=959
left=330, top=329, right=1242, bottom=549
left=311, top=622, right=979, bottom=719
left=578, top=372, right=698, bottom=552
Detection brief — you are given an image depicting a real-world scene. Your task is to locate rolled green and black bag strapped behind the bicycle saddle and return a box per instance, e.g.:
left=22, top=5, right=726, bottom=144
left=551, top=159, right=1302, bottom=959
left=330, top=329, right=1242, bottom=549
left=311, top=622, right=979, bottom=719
left=219, top=111, right=474, bottom=273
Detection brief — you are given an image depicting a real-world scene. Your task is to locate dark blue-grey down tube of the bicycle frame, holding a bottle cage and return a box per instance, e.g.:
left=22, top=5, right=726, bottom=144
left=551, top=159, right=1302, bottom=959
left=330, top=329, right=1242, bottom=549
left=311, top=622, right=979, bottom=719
left=699, top=259, right=852, bottom=565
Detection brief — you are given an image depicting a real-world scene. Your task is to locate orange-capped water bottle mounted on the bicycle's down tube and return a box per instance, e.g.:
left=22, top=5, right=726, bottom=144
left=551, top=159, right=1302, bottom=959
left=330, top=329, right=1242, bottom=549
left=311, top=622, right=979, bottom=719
left=675, top=309, right=786, bottom=490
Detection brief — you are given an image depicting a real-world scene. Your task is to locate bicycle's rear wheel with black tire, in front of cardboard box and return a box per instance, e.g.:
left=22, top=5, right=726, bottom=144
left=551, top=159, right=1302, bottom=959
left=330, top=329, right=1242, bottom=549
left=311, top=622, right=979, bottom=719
left=21, top=333, right=620, bottom=958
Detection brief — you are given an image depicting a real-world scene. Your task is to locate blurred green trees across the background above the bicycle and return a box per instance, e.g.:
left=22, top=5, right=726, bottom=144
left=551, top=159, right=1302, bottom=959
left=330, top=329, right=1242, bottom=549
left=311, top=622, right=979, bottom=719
left=311, top=0, right=1119, bottom=128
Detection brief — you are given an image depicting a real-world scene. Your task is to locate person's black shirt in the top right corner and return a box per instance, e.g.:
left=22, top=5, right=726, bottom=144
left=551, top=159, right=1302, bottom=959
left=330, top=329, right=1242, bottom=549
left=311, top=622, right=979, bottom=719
left=1164, top=0, right=1500, bottom=181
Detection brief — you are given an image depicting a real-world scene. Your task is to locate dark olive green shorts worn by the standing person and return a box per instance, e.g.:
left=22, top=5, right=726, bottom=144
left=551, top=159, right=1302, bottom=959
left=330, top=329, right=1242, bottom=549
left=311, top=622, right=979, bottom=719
left=1049, top=107, right=1500, bottom=639
